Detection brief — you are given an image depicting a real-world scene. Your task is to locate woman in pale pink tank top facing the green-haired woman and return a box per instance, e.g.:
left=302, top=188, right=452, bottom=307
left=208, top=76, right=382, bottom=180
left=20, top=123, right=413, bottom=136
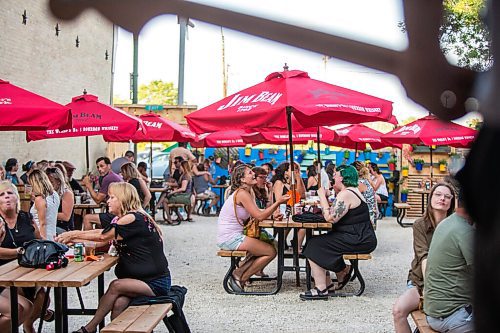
left=217, top=164, right=290, bottom=292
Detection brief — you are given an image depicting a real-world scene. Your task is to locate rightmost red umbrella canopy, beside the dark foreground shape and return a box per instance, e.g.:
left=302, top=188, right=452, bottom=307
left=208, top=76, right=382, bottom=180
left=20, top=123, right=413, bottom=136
left=382, top=115, right=477, bottom=147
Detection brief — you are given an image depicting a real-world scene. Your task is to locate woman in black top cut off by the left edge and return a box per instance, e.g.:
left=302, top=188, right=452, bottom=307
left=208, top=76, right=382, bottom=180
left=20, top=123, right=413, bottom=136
left=0, top=181, right=54, bottom=332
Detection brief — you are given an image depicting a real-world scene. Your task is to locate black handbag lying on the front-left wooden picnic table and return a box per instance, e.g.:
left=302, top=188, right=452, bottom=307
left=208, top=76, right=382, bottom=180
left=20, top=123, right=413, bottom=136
left=17, top=239, right=68, bottom=268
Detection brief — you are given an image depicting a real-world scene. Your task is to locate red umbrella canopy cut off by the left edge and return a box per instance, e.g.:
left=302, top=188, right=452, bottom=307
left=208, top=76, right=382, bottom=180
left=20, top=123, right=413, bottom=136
left=0, top=80, right=71, bottom=131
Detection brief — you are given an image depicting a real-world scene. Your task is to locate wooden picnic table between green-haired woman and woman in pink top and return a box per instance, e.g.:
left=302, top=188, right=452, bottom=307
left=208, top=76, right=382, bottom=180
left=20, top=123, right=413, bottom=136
left=259, top=218, right=332, bottom=293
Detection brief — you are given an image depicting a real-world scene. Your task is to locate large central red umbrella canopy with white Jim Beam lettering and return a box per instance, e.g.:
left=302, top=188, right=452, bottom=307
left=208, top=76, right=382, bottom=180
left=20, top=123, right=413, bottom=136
left=186, top=70, right=392, bottom=133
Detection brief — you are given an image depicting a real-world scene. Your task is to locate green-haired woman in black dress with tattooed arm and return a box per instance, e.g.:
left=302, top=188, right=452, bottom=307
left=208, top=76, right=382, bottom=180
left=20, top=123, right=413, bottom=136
left=300, top=165, right=377, bottom=300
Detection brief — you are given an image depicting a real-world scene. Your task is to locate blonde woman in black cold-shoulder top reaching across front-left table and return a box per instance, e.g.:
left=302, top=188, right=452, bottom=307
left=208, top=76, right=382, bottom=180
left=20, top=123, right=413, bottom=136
left=57, top=183, right=171, bottom=333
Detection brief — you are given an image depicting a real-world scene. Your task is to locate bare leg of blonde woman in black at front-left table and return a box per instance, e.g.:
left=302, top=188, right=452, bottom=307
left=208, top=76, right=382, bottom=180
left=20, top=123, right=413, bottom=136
left=80, top=279, right=154, bottom=332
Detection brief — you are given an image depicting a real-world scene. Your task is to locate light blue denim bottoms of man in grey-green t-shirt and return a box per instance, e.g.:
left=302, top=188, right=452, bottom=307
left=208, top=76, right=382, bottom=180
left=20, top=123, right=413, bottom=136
left=427, top=305, right=475, bottom=333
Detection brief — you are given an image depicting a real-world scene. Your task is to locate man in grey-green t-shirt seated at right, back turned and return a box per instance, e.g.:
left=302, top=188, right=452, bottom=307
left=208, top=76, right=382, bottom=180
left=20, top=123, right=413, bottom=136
left=424, top=189, right=475, bottom=333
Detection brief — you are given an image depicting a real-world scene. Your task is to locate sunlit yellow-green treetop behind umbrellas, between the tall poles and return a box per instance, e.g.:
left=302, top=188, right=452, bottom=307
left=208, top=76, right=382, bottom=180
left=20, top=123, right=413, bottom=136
left=137, top=80, right=177, bottom=105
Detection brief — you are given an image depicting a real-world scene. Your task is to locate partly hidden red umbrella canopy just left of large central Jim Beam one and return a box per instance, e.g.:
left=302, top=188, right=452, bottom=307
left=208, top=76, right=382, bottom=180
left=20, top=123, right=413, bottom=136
left=104, top=113, right=197, bottom=142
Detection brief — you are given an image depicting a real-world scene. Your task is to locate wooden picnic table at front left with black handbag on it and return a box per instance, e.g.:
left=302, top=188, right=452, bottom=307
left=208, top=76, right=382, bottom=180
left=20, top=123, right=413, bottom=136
left=0, top=254, right=118, bottom=333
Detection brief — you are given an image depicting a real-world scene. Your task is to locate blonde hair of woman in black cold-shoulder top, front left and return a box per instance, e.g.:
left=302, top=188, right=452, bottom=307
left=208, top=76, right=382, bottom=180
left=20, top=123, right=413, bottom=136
left=108, top=182, right=162, bottom=236
